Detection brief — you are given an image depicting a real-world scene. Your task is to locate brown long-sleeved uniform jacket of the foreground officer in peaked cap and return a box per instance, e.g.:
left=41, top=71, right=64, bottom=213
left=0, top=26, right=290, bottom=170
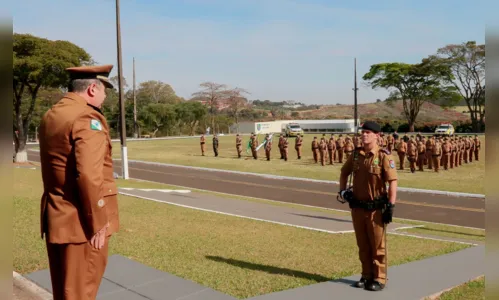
left=40, top=93, right=119, bottom=243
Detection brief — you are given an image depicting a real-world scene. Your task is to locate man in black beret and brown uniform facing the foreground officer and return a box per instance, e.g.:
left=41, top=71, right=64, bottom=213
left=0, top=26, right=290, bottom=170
left=339, top=121, right=397, bottom=291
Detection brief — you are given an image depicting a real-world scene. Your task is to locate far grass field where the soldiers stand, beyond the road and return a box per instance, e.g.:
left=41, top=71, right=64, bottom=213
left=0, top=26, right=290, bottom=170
left=108, top=135, right=485, bottom=194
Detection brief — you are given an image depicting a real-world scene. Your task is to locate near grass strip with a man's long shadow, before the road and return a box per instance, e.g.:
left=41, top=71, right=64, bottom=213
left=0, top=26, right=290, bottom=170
left=13, top=169, right=467, bottom=298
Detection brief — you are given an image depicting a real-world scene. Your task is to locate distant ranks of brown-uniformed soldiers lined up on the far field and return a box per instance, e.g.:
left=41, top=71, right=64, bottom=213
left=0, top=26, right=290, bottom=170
left=200, top=132, right=481, bottom=173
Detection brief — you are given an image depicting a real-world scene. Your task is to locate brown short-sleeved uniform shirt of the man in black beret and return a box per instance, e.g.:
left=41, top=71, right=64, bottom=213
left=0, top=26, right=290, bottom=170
left=341, top=145, right=397, bottom=201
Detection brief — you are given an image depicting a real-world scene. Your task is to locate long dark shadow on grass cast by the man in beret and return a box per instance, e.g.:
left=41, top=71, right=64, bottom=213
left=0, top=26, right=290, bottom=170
left=206, top=255, right=331, bottom=282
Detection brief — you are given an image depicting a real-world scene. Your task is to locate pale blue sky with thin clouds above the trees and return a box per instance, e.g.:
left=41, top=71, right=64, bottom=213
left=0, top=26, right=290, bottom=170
left=8, top=0, right=499, bottom=104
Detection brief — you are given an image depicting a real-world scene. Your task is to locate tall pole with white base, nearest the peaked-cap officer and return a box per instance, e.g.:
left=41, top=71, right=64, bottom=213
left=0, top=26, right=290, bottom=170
left=116, top=0, right=128, bottom=179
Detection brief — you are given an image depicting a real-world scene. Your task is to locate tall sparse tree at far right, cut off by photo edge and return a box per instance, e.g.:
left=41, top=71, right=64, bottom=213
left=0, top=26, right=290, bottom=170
left=428, top=41, right=485, bottom=132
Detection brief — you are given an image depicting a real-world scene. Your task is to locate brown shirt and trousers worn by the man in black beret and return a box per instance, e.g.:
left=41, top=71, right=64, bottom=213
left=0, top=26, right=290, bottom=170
left=341, top=146, right=397, bottom=284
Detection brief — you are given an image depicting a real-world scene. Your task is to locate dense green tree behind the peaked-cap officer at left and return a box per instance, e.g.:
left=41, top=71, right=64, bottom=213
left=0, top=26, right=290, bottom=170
left=13, top=33, right=93, bottom=162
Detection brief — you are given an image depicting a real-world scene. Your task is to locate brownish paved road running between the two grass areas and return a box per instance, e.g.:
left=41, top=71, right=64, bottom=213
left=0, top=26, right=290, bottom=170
left=28, top=151, right=485, bottom=229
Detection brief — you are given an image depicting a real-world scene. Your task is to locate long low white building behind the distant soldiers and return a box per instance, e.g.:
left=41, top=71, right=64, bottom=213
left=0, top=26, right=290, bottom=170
left=230, top=119, right=360, bottom=134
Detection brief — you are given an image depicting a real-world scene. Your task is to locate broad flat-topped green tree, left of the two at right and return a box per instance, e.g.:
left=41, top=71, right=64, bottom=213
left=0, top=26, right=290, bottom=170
left=363, top=60, right=452, bottom=131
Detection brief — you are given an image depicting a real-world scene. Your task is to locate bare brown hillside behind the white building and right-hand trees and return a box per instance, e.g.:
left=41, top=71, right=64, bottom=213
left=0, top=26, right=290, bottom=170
left=299, top=101, right=469, bottom=122
